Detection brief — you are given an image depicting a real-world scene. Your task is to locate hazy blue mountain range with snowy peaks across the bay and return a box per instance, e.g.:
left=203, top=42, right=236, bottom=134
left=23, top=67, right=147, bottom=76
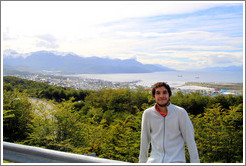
left=3, top=50, right=174, bottom=74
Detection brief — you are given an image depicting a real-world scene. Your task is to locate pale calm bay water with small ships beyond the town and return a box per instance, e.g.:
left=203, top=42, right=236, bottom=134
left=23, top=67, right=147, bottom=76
left=70, top=71, right=244, bottom=87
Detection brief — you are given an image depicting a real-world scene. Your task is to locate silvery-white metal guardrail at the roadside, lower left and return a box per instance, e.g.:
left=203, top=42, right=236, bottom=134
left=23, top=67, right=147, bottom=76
left=3, top=142, right=127, bottom=164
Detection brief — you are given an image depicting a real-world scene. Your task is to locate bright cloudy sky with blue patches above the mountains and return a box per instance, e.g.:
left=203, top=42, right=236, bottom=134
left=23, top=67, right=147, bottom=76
left=1, top=1, right=245, bottom=70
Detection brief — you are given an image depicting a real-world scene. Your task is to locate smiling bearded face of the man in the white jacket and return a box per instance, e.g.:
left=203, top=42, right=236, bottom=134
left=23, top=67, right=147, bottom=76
left=153, top=86, right=170, bottom=107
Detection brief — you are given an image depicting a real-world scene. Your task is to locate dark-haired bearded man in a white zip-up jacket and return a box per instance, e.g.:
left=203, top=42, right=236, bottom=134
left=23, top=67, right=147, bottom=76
left=139, top=82, right=200, bottom=163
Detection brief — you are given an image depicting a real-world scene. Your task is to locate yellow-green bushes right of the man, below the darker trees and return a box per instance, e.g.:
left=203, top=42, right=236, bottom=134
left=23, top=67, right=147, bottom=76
left=192, top=104, right=243, bottom=163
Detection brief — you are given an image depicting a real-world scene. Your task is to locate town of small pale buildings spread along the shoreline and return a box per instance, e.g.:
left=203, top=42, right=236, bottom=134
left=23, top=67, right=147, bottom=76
left=4, top=74, right=242, bottom=96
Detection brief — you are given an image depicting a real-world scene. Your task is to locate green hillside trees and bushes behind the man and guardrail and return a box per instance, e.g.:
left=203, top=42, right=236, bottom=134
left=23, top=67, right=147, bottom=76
left=3, top=76, right=243, bottom=163
